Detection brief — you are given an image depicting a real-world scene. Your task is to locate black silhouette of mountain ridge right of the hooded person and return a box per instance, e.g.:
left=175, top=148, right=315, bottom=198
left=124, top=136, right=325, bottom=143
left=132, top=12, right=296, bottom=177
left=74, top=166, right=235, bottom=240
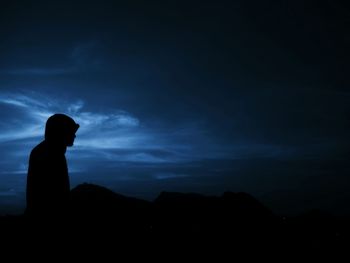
left=71, top=183, right=275, bottom=231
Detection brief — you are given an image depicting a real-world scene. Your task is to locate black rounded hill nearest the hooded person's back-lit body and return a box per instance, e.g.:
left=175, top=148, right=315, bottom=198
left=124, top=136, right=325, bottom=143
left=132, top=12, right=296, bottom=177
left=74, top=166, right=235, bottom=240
left=71, top=183, right=152, bottom=233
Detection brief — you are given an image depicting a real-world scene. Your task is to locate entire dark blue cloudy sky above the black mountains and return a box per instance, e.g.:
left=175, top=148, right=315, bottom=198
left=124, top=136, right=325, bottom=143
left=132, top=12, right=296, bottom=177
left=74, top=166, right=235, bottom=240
left=0, top=0, right=350, bottom=217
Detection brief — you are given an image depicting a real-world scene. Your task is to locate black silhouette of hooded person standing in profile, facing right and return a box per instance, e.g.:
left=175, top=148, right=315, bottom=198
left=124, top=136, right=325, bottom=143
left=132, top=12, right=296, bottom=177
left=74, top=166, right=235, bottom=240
left=26, top=114, right=79, bottom=219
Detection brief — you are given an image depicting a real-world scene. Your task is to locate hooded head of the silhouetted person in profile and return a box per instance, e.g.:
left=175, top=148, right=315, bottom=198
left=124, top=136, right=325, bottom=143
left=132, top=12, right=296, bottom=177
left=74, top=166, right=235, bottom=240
left=45, top=113, right=79, bottom=146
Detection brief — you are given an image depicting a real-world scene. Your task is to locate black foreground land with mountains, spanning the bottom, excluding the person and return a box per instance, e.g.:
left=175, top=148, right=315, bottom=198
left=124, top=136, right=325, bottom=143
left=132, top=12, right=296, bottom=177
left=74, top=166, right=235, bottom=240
left=0, top=184, right=350, bottom=262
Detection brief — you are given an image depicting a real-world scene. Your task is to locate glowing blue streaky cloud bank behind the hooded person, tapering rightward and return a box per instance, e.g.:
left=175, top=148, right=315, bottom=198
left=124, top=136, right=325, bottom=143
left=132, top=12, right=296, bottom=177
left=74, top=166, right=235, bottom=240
left=0, top=91, right=304, bottom=184
